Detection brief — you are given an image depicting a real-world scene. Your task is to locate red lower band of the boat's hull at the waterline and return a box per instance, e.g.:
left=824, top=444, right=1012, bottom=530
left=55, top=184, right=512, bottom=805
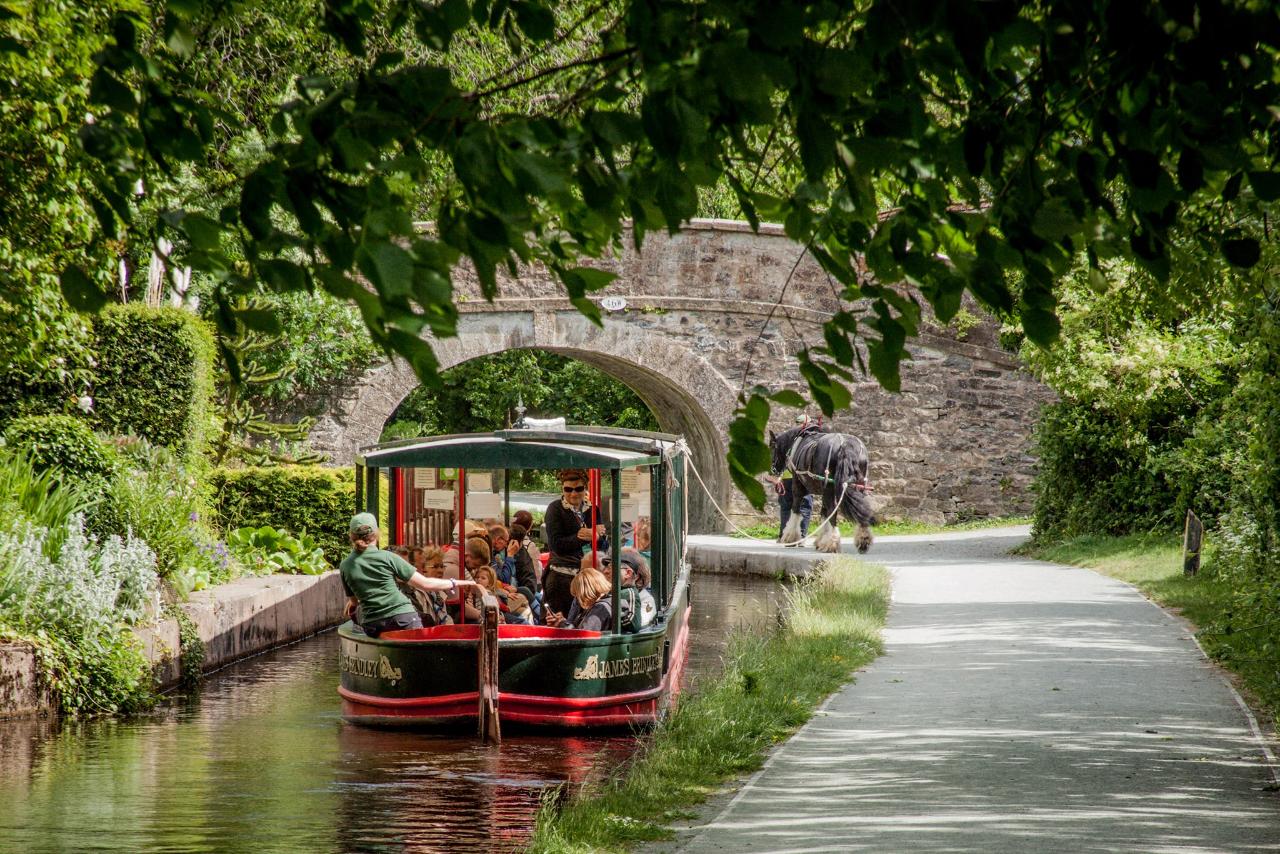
left=338, top=614, right=689, bottom=727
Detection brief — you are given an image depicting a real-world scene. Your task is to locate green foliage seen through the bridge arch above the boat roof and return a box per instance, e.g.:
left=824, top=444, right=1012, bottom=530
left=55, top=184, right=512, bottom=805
left=383, top=350, right=659, bottom=440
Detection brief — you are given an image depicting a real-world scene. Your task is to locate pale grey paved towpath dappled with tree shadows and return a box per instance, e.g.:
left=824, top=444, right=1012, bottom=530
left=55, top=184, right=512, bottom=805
left=663, top=529, right=1280, bottom=854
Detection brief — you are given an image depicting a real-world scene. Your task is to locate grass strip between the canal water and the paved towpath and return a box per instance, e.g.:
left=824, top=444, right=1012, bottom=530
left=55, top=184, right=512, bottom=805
left=530, top=557, right=888, bottom=851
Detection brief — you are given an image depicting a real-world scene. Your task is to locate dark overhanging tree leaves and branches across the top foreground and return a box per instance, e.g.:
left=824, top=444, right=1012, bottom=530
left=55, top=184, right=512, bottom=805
left=63, top=0, right=1280, bottom=501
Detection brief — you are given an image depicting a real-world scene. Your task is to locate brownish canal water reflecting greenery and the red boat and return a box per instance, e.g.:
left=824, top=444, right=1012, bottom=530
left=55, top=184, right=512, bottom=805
left=0, top=574, right=783, bottom=854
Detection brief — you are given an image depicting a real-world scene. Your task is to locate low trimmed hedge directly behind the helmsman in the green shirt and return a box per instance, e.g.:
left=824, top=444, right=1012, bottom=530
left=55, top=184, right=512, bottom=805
left=210, top=466, right=356, bottom=565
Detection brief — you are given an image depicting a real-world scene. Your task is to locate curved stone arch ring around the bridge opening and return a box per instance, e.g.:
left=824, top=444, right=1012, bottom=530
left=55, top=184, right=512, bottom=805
left=310, top=311, right=736, bottom=531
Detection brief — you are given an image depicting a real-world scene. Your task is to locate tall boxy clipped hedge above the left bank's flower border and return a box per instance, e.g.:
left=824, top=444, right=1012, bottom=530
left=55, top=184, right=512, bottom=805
left=93, top=303, right=214, bottom=457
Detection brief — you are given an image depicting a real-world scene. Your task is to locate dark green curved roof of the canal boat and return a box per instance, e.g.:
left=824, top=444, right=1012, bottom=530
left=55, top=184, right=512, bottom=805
left=356, top=424, right=684, bottom=469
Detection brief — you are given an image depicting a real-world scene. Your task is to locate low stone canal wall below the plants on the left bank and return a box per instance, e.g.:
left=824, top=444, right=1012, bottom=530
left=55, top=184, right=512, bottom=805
left=0, top=571, right=346, bottom=718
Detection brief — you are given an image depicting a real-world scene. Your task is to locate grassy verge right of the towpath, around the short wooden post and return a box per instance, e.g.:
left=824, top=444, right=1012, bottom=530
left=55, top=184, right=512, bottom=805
left=1021, top=534, right=1280, bottom=725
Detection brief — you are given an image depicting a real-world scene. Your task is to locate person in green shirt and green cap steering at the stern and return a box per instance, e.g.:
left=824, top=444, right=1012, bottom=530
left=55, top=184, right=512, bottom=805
left=338, top=513, right=475, bottom=638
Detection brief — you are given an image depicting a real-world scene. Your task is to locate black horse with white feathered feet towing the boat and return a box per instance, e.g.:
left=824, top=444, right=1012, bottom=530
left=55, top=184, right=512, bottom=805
left=769, top=424, right=876, bottom=552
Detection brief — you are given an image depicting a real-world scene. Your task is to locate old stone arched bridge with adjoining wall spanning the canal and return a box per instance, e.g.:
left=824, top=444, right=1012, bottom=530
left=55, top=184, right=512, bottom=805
left=299, top=220, right=1051, bottom=530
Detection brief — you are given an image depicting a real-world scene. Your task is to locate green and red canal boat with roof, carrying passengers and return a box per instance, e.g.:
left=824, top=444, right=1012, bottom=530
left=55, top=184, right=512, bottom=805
left=338, top=425, right=690, bottom=727
